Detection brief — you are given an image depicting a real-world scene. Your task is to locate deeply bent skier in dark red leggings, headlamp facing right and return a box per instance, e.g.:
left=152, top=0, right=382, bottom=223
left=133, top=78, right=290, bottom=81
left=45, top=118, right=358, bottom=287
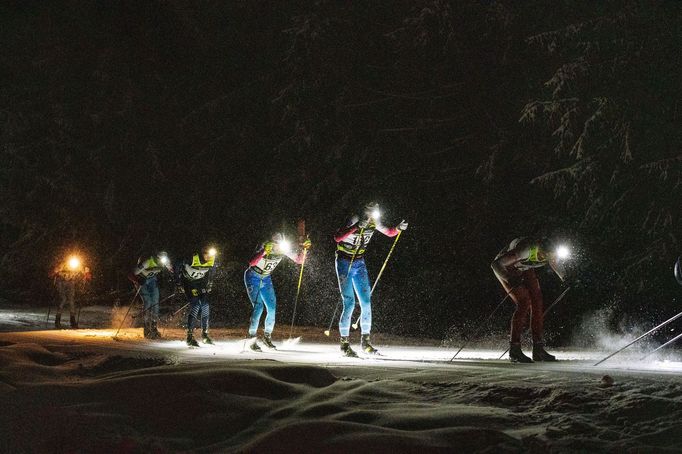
left=491, top=237, right=564, bottom=363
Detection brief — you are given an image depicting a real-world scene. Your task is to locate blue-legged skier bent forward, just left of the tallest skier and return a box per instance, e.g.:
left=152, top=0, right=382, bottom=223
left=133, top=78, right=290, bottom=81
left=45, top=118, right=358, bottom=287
left=244, top=233, right=312, bottom=351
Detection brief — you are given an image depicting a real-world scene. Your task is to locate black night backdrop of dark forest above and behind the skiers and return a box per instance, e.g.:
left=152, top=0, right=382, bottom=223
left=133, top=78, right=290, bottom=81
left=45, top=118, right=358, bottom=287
left=0, top=0, right=682, bottom=342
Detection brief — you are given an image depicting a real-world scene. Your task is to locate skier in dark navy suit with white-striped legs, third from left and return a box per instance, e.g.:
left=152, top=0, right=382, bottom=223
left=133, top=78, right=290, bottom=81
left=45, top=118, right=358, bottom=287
left=173, top=247, right=216, bottom=347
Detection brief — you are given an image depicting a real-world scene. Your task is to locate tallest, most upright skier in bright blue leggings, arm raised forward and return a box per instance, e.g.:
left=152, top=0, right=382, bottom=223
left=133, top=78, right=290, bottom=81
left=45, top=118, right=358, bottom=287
left=334, top=203, right=407, bottom=357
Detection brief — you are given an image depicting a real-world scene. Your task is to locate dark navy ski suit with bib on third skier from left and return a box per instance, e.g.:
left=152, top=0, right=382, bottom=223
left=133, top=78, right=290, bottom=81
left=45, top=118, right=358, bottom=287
left=174, top=254, right=215, bottom=332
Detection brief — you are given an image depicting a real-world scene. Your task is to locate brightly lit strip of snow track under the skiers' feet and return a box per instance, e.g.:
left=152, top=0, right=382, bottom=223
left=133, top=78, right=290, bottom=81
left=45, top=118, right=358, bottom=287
left=6, top=329, right=682, bottom=374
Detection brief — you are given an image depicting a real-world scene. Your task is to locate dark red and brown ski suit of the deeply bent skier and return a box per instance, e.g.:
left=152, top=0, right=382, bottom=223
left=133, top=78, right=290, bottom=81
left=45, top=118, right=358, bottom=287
left=491, top=238, right=549, bottom=344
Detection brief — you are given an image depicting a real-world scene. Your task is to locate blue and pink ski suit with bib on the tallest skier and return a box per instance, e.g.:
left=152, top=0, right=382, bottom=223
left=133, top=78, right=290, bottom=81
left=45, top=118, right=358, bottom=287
left=334, top=216, right=399, bottom=337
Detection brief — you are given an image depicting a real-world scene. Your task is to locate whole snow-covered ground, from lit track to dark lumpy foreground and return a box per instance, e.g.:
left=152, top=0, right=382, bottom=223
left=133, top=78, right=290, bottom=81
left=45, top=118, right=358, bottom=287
left=0, top=306, right=682, bottom=452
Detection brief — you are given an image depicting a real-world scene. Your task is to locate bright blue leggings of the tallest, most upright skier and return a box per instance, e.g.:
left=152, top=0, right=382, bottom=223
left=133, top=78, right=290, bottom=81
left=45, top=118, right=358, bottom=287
left=336, top=257, right=372, bottom=337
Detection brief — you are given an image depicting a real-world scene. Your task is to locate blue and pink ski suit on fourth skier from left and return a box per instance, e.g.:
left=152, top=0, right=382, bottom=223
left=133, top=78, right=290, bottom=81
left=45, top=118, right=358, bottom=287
left=244, top=243, right=303, bottom=337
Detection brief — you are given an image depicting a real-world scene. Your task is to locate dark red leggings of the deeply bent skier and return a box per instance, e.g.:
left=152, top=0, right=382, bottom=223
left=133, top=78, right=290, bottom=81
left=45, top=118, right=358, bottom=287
left=500, top=270, right=544, bottom=343
